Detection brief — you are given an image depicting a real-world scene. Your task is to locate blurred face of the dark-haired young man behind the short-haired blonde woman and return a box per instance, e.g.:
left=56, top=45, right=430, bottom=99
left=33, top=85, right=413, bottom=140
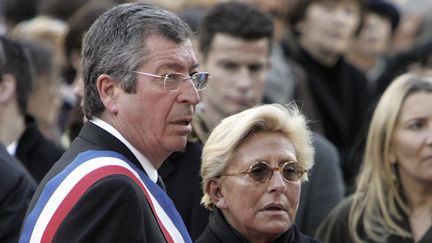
left=203, top=33, right=269, bottom=118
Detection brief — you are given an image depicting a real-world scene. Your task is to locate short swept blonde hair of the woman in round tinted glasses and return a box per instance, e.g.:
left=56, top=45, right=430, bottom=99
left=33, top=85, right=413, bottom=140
left=201, top=104, right=314, bottom=209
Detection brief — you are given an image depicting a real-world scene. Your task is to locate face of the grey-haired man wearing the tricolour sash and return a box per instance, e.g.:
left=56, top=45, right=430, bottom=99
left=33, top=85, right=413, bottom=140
left=116, top=35, right=200, bottom=166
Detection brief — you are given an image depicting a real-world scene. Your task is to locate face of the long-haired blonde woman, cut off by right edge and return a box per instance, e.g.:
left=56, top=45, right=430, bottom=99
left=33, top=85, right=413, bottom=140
left=390, top=92, right=432, bottom=186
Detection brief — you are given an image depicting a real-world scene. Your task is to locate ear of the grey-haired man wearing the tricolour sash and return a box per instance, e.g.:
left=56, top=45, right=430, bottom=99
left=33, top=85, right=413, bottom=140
left=96, top=74, right=122, bottom=114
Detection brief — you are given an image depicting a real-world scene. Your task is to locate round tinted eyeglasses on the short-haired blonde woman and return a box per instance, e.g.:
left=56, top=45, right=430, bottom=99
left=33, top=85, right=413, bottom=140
left=221, top=161, right=307, bottom=183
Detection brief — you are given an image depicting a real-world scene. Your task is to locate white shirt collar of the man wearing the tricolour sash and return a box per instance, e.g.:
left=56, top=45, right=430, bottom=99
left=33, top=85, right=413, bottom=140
left=90, top=117, right=158, bottom=183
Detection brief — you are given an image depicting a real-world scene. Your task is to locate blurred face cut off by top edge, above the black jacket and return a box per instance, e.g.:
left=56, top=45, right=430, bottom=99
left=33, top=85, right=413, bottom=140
left=295, top=0, right=360, bottom=55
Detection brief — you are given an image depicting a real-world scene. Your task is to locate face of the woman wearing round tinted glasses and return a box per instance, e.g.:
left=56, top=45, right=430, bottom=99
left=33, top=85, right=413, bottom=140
left=215, top=132, right=300, bottom=240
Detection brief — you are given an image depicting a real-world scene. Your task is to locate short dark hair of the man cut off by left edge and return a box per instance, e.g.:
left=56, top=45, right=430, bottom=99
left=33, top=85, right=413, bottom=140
left=0, top=37, right=33, bottom=115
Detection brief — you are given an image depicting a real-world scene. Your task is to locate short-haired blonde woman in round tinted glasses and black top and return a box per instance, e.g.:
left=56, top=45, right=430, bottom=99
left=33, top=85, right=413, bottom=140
left=197, top=104, right=318, bottom=243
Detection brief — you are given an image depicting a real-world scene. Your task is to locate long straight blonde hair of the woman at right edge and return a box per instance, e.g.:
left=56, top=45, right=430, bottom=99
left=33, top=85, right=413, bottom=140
left=349, top=69, right=432, bottom=242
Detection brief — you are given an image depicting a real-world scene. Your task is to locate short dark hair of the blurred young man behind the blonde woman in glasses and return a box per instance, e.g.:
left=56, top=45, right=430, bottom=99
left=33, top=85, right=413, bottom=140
left=198, top=2, right=273, bottom=58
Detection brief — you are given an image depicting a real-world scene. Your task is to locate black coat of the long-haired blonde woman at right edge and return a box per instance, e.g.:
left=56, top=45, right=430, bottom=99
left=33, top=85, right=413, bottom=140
left=316, top=196, right=432, bottom=243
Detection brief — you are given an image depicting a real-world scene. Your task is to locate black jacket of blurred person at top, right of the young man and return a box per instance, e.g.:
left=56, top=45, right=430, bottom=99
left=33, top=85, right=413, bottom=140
left=286, top=44, right=370, bottom=188
